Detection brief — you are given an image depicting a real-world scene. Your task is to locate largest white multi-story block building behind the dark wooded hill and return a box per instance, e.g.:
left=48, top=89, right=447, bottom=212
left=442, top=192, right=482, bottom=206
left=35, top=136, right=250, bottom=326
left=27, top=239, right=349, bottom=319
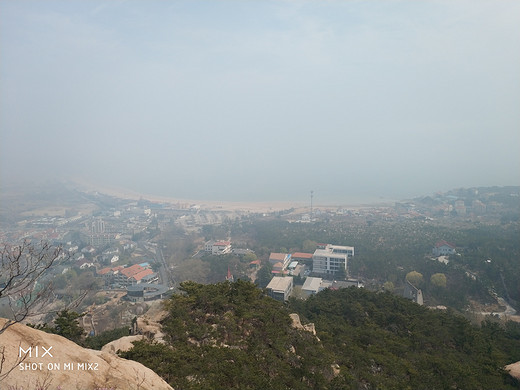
left=312, top=244, right=354, bottom=275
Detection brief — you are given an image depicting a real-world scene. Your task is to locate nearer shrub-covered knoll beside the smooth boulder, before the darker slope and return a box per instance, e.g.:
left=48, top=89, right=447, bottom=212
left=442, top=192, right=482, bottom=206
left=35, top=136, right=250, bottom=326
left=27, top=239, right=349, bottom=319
left=122, top=281, right=333, bottom=389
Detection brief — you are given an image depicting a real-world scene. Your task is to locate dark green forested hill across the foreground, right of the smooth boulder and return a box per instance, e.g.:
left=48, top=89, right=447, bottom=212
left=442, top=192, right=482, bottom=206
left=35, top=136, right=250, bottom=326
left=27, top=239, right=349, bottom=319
left=122, top=281, right=520, bottom=390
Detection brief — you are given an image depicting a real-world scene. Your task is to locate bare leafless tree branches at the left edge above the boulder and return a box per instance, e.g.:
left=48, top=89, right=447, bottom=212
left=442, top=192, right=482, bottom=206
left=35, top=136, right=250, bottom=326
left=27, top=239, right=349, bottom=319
left=0, top=241, right=69, bottom=334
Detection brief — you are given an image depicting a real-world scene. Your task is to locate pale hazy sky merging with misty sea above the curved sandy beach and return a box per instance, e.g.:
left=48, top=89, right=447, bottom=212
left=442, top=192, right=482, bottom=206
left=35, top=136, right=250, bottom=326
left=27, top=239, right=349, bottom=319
left=0, top=0, right=520, bottom=201
